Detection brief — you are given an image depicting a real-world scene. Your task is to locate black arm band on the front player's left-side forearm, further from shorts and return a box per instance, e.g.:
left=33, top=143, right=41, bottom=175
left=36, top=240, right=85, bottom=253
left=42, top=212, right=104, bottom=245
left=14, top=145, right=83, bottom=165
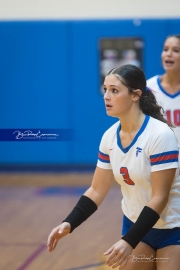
left=63, top=195, right=97, bottom=232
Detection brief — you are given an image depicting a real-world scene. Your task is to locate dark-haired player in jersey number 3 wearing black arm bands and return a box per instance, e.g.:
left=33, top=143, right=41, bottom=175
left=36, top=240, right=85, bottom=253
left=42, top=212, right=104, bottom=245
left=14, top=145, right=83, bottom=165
left=47, top=65, right=180, bottom=270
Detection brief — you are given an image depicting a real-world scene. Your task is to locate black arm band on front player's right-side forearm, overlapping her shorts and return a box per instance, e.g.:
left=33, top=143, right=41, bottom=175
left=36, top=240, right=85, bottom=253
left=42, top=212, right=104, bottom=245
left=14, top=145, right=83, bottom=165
left=122, top=206, right=159, bottom=248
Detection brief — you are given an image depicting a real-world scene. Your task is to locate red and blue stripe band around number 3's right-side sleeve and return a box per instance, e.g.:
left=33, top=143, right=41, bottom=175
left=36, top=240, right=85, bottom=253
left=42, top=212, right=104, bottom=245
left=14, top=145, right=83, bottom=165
left=150, top=151, right=179, bottom=166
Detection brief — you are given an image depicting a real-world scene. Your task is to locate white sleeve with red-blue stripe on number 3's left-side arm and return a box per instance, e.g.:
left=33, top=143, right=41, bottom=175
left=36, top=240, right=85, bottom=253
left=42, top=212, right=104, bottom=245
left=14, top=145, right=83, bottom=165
left=97, top=132, right=112, bottom=170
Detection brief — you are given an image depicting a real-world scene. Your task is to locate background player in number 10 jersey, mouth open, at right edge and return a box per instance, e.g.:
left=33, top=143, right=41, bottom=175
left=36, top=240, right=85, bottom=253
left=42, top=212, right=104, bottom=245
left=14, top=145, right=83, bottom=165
left=147, top=35, right=180, bottom=167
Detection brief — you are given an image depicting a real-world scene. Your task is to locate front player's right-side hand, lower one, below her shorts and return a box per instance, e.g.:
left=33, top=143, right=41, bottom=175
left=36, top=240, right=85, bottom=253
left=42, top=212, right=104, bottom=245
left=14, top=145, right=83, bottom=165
left=104, top=239, right=133, bottom=269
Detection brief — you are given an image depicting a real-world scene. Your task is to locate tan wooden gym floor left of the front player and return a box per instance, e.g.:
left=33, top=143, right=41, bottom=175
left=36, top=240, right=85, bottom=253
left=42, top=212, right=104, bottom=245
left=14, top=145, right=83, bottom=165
left=0, top=172, right=122, bottom=270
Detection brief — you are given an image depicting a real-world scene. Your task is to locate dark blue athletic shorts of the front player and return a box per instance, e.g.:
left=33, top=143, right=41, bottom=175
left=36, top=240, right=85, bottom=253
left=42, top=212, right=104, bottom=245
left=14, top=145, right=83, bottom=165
left=122, top=216, right=180, bottom=250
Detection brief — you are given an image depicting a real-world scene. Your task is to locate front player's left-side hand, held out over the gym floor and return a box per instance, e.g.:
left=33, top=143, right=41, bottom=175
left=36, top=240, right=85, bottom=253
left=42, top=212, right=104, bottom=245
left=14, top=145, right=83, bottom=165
left=47, top=222, right=71, bottom=252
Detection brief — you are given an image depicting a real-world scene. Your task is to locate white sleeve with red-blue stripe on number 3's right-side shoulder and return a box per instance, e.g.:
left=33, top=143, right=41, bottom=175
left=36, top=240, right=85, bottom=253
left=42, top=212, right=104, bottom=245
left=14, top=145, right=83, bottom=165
left=149, top=128, right=179, bottom=172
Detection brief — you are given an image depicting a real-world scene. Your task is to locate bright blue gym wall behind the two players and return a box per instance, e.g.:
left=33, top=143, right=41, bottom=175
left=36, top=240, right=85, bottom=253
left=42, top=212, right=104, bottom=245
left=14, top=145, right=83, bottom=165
left=0, top=19, right=180, bottom=168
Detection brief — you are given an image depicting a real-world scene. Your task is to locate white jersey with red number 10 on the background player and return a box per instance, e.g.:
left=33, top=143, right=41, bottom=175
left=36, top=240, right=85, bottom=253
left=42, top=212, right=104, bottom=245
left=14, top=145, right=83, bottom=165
left=147, top=75, right=180, bottom=158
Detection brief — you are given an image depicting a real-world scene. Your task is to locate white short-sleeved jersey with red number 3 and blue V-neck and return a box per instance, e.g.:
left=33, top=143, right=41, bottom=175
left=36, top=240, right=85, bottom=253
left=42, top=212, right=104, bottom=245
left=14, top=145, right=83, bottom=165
left=97, top=115, right=180, bottom=228
